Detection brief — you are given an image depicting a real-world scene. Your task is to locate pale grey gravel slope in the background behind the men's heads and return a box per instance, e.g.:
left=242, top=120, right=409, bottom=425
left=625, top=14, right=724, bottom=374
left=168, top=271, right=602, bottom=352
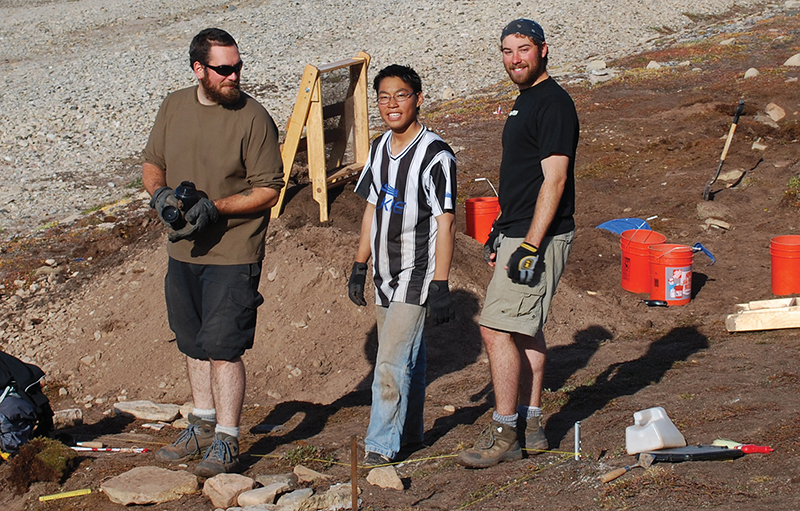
left=0, top=0, right=771, bottom=240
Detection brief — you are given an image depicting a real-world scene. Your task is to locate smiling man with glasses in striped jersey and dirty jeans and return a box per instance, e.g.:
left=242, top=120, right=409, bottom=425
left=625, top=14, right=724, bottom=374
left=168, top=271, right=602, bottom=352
left=348, top=65, right=456, bottom=466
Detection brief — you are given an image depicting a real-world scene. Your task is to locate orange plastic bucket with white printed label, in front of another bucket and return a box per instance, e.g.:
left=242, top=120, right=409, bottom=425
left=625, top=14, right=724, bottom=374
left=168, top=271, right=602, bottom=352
left=650, top=243, right=694, bottom=305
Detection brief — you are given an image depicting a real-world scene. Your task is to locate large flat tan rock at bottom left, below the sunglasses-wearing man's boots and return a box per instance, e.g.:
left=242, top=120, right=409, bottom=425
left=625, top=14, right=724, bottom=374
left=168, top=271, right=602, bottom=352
left=100, top=467, right=197, bottom=506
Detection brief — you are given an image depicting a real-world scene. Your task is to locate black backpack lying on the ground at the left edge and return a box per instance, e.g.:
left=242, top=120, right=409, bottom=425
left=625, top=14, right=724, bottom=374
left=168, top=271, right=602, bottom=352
left=0, top=351, right=53, bottom=454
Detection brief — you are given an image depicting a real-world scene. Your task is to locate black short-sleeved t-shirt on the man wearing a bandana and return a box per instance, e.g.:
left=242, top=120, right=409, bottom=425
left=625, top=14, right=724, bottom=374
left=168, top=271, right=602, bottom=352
left=495, top=78, right=580, bottom=238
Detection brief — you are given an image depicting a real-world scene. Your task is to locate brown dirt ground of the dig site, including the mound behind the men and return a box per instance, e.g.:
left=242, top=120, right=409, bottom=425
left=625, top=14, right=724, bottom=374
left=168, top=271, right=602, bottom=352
left=0, top=9, right=800, bottom=510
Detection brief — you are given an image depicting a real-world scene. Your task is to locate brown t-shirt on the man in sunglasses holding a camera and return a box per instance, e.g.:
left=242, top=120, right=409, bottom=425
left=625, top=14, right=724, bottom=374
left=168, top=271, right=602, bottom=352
left=144, top=86, right=283, bottom=265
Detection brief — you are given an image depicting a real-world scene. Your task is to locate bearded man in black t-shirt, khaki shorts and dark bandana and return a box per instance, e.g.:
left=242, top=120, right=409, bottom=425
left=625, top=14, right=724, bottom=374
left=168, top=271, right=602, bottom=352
left=458, top=19, right=579, bottom=468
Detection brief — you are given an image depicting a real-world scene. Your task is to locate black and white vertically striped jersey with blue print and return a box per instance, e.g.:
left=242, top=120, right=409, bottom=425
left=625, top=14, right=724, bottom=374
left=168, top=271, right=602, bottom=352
left=356, top=126, right=456, bottom=307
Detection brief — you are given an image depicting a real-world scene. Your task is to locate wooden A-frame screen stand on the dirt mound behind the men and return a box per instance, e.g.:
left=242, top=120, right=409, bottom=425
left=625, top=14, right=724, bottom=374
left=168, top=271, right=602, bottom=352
left=270, top=51, right=370, bottom=222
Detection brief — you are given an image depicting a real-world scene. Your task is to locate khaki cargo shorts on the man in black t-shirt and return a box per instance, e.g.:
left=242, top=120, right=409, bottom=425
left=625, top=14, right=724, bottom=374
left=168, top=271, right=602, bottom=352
left=479, top=231, right=575, bottom=336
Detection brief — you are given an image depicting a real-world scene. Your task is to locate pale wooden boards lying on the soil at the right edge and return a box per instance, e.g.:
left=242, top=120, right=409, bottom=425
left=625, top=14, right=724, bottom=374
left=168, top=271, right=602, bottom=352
left=725, top=298, right=800, bottom=332
